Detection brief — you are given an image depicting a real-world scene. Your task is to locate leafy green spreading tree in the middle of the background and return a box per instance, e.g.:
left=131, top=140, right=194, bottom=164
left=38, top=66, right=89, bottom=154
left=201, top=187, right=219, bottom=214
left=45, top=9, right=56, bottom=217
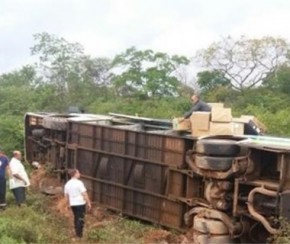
left=112, top=47, right=189, bottom=98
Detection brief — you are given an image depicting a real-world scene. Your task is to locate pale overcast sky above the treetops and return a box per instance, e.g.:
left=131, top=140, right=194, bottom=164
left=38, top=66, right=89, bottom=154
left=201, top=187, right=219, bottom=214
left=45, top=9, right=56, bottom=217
left=0, top=0, right=290, bottom=74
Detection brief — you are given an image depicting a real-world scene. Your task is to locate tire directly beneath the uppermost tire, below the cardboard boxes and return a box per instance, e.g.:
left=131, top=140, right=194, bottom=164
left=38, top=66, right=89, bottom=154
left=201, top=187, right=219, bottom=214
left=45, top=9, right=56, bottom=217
left=195, top=155, right=235, bottom=171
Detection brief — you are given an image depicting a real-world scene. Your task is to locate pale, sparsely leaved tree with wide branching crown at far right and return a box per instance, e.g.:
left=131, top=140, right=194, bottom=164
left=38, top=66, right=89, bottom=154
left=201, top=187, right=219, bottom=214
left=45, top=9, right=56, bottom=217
left=196, top=36, right=289, bottom=92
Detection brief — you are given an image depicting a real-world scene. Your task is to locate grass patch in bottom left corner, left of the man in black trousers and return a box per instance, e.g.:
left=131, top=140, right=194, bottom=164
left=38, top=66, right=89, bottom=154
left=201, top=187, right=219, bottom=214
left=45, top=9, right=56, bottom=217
left=0, top=191, right=70, bottom=243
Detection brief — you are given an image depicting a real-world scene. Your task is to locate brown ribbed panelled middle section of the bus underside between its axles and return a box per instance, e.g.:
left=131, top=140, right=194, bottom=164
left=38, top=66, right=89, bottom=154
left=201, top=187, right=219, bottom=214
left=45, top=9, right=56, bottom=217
left=28, top=116, right=194, bottom=229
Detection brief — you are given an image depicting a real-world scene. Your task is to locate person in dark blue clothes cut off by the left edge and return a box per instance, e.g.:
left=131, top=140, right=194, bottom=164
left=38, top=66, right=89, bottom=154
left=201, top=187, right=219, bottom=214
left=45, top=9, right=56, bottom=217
left=0, top=148, right=9, bottom=209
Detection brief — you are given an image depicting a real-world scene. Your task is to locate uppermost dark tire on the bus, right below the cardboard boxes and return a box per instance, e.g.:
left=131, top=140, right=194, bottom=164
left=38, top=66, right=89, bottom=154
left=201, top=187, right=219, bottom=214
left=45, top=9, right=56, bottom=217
left=196, top=139, right=240, bottom=157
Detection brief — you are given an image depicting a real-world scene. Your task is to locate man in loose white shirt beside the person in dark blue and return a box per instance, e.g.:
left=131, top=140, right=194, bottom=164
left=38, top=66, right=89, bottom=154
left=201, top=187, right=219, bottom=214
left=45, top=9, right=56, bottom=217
left=9, top=151, right=30, bottom=206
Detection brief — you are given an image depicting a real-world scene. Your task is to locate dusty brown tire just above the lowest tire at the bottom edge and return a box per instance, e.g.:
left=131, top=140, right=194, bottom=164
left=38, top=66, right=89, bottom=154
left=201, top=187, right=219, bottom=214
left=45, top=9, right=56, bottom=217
left=193, top=215, right=229, bottom=235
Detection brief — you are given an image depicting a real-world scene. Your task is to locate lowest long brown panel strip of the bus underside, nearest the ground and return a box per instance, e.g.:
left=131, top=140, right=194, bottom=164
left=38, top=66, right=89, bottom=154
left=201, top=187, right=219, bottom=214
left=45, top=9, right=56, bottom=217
left=92, top=177, right=185, bottom=229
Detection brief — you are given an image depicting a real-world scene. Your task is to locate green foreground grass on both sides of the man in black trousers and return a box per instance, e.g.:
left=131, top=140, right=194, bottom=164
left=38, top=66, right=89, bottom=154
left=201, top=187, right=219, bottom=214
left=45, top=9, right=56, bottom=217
left=0, top=185, right=172, bottom=244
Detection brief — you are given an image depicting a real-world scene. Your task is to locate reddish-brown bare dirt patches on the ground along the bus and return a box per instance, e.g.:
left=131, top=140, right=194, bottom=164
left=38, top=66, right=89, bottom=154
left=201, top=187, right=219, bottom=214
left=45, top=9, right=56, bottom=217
left=31, top=168, right=193, bottom=244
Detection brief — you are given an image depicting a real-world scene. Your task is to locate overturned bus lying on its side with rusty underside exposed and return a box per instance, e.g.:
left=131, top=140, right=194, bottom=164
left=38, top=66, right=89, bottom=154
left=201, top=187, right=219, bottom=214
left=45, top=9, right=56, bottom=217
left=25, top=113, right=290, bottom=243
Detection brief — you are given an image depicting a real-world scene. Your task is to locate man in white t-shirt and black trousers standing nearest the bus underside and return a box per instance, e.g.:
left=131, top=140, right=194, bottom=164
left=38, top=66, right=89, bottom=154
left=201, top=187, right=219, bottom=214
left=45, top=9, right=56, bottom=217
left=64, top=169, right=91, bottom=238
